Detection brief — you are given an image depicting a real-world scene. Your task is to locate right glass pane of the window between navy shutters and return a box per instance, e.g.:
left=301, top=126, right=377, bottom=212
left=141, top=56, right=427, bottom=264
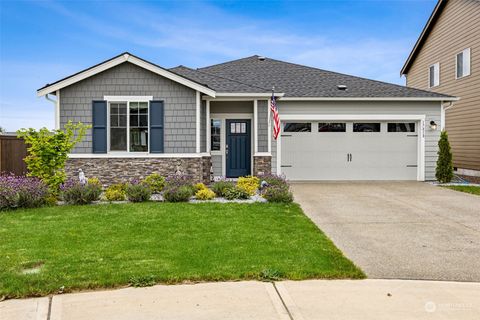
left=130, top=102, right=148, bottom=152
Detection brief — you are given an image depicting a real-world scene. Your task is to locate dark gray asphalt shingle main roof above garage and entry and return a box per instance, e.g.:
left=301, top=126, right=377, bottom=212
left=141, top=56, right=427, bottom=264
left=170, top=55, right=450, bottom=98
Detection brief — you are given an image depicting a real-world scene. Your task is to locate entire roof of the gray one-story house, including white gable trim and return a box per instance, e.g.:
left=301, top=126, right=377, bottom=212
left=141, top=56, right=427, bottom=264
left=37, top=52, right=456, bottom=101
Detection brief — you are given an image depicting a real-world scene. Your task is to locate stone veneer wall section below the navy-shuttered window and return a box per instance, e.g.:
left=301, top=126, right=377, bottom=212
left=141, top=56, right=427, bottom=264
left=65, top=157, right=211, bottom=185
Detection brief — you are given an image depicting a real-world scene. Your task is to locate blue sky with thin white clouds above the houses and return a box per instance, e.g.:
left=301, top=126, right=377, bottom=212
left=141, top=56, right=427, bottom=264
left=0, top=0, right=437, bottom=131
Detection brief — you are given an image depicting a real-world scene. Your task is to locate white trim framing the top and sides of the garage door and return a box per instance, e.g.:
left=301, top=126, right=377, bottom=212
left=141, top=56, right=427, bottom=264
left=276, top=114, right=426, bottom=181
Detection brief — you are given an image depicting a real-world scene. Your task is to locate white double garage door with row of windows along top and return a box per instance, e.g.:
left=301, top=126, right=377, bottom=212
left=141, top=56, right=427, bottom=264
left=281, top=121, right=418, bottom=180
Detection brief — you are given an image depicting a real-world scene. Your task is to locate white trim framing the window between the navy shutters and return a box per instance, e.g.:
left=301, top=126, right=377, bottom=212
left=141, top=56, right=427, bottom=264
left=103, top=96, right=153, bottom=157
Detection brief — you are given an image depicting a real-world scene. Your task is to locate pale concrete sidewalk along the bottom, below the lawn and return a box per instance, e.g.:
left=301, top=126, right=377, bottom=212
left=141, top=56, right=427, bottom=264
left=0, top=280, right=480, bottom=320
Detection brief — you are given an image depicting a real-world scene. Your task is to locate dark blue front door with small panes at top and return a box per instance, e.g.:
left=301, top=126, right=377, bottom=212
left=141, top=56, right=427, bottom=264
left=226, top=120, right=251, bottom=178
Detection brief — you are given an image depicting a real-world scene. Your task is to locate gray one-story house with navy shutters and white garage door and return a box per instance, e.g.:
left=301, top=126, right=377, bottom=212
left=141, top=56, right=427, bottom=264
left=37, top=53, right=456, bottom=183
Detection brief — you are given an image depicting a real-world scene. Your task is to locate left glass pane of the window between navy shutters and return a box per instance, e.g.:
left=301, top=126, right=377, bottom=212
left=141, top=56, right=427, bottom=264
left=110, top=103, right=127, bottom=151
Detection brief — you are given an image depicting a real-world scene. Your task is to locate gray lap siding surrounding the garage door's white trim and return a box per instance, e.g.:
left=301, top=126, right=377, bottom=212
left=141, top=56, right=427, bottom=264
left=272, top=100, right=441, bottom=180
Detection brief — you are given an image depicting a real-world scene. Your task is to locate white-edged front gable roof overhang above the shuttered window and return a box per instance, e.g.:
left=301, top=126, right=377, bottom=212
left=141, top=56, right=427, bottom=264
left=37, top=52, right=215, bottom=97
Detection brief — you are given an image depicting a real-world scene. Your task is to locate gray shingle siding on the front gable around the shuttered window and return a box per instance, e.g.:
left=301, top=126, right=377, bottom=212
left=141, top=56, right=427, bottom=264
left=60, top=62, right=196, bottom=153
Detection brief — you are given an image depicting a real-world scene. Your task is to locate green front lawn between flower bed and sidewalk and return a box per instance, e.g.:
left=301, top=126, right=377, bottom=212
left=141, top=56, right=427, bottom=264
left=0, top=203, right=365, bottom=298
